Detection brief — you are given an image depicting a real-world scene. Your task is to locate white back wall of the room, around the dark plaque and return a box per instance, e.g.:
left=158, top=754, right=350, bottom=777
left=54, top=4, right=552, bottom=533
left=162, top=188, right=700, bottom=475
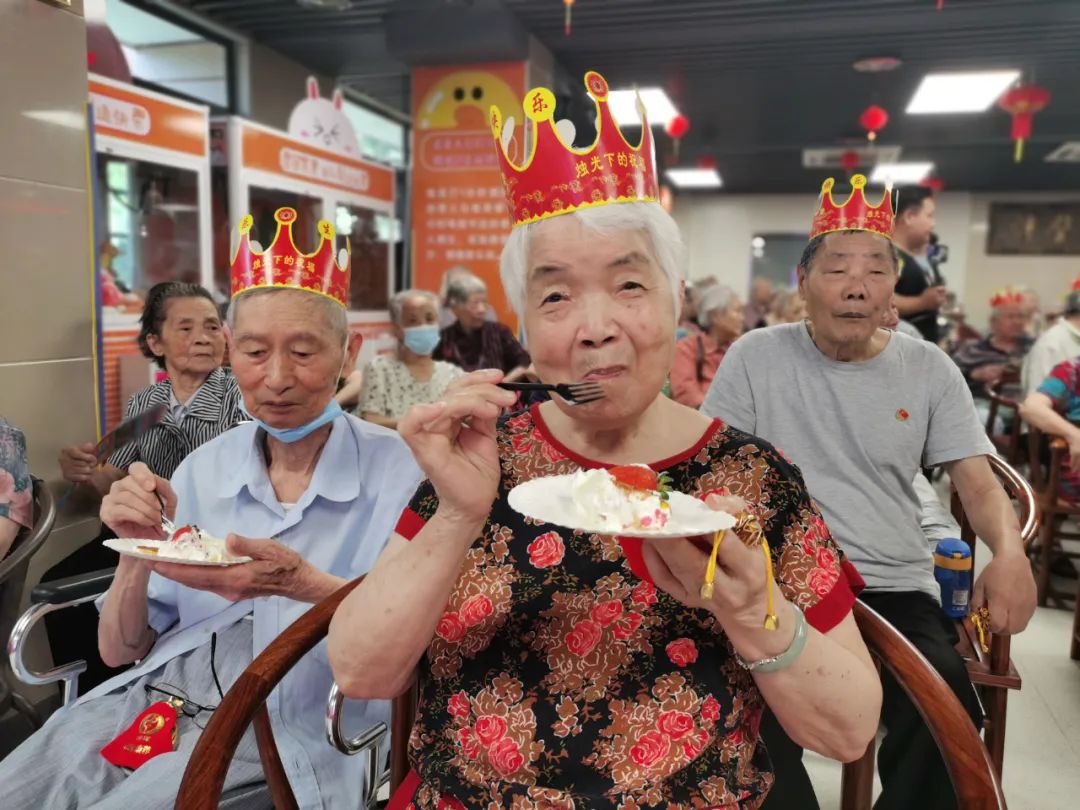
left=674, top=191, right=1080, bottom=329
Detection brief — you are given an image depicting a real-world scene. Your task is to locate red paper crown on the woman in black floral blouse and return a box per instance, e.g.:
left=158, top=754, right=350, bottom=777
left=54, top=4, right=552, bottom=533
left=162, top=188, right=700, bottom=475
left=491, top=70, right=660, bottom=228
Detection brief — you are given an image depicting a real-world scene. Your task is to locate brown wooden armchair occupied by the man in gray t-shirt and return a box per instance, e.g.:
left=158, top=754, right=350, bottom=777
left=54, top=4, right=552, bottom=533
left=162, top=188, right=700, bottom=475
left=953, top=456, right=1039, bottom=777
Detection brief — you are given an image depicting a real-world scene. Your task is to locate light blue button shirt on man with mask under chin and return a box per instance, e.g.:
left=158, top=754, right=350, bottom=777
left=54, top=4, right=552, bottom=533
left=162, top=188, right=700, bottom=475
left=86, top=415, right=420, bottom=808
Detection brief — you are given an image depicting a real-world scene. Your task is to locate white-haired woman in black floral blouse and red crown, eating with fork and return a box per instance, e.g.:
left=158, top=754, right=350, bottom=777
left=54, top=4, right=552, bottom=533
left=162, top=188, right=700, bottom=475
left=329, top=73, right=881, bottom=810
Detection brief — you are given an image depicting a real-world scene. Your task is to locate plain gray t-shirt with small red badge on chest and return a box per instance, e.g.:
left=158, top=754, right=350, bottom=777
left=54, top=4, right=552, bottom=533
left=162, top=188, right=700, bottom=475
left=701, top=323, right=994, bottom=599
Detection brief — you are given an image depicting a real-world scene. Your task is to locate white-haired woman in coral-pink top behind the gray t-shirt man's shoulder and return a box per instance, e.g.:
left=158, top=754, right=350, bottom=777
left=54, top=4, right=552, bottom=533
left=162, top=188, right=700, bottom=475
left=671, top=284, right=743, bottom=408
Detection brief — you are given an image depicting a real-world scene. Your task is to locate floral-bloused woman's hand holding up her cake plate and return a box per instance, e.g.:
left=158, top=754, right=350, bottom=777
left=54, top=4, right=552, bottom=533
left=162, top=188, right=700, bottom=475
left=642, top=495, right=775, bottom=634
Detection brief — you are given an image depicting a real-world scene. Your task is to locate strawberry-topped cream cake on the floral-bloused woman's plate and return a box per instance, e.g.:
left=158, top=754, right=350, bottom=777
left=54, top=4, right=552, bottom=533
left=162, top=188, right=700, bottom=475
left=570, top=464, right=671, bottom=531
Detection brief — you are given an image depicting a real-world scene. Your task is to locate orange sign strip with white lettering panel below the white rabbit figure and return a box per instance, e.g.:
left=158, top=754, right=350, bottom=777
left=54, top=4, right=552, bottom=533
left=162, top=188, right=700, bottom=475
left=241, top=121, right=394, bottom=202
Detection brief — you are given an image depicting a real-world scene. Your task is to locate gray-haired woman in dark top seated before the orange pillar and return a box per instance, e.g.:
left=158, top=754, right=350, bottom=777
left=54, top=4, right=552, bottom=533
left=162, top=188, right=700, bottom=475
left=435, top=274, right=530, bottom=382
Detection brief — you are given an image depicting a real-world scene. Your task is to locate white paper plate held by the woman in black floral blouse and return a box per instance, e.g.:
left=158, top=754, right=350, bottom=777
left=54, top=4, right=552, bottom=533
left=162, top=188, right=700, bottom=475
left=510, top=475, right=735, bottom=538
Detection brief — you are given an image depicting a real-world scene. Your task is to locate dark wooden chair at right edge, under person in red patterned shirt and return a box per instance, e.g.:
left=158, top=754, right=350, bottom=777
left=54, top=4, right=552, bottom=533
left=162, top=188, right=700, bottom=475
left=1028, top=426, right=1080, bottom=608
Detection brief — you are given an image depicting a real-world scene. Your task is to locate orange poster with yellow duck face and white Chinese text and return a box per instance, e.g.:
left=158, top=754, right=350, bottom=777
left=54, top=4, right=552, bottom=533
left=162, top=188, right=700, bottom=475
left=411, top=62, right=527, bottom=328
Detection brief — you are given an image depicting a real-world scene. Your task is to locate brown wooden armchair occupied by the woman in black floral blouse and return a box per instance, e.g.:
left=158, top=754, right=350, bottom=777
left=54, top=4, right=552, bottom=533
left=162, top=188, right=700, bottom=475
left=176, top=580, right=1005, bottom=810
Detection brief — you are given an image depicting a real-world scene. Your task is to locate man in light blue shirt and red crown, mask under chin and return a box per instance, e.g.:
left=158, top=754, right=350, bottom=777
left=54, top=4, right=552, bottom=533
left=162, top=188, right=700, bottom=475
left=0, top=208, right=420, bottom=810
